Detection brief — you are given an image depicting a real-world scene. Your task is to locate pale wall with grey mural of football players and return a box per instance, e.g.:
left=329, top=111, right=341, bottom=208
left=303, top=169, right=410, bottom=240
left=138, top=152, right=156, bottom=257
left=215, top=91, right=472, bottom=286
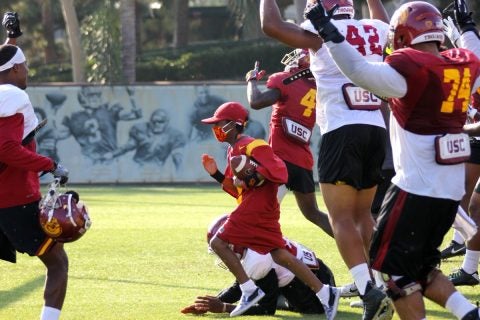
left=27, top=83, right=319, bottom=183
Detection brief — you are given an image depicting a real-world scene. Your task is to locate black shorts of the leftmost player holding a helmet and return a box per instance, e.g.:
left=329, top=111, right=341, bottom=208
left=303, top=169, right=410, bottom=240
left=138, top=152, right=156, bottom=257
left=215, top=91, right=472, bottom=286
left=0, top=201, right=54, bottom=262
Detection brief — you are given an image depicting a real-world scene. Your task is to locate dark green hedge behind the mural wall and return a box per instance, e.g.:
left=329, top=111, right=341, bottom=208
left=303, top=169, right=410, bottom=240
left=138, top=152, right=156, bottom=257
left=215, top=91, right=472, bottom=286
left=30, top=40, right=292, bottom=83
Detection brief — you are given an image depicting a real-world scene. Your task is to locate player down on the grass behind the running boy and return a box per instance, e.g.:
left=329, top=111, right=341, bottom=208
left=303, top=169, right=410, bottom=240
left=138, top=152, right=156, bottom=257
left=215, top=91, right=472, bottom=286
left=182, top=214, right=335, bottom=315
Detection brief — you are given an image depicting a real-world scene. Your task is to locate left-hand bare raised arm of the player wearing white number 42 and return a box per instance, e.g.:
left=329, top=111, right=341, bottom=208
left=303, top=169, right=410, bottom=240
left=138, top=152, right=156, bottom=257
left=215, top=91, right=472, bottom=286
left=260, top=0, right=322, bottom=51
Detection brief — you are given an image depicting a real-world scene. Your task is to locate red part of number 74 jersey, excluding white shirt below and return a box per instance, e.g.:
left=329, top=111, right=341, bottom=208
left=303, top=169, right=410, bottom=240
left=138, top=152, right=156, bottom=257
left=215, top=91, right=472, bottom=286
left=385, top=48, right=480, bottom=135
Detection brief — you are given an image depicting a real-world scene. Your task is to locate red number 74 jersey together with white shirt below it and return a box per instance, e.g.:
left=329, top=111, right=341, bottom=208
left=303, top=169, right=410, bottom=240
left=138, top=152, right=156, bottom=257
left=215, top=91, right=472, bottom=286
left=385, top=48, right=480, bottom=201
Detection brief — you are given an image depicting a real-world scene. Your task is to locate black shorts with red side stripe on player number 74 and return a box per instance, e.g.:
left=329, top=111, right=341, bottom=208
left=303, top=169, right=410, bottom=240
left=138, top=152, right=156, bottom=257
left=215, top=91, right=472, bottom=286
left=370, top=184, right=459, bottom=282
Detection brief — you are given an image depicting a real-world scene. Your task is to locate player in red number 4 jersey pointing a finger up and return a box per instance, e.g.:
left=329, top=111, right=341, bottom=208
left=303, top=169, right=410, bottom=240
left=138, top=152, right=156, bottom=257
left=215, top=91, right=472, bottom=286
left=245, top=49, right=333, bottom=237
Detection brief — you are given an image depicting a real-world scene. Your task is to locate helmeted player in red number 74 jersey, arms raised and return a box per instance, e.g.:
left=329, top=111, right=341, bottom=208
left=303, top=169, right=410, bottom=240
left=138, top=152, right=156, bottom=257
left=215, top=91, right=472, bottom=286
left=306, top=0, right=480, bottom=320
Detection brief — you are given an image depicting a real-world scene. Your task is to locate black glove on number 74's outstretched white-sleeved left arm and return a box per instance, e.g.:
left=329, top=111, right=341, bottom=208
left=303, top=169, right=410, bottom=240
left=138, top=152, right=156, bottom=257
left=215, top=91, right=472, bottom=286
left=304, top=2, right=345, bottom=43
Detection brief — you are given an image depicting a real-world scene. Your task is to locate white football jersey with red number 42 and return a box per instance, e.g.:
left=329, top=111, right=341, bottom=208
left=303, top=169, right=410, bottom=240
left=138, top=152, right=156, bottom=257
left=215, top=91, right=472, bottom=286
left=301, top=19, right=389, bottom=134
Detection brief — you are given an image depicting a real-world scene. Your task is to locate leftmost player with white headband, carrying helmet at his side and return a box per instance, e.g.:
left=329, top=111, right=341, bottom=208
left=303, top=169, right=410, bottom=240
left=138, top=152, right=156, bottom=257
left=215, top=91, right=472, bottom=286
left=0, top=12, right=68, bottom=320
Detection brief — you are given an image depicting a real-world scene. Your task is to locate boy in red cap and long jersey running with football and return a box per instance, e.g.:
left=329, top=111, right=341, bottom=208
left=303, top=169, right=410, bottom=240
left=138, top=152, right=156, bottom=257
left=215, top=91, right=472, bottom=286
left=202, top=102, right=339, bottom=319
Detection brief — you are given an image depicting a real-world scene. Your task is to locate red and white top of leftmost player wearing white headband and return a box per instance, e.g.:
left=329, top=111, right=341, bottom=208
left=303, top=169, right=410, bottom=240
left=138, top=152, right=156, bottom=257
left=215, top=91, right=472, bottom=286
left=0, top=85, right=53, bottom=208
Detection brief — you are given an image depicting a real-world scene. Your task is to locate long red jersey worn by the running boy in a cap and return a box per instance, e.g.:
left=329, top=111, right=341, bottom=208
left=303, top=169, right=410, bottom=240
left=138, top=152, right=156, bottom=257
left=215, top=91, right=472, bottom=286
left=218, top=136, right=288, bottom=254
